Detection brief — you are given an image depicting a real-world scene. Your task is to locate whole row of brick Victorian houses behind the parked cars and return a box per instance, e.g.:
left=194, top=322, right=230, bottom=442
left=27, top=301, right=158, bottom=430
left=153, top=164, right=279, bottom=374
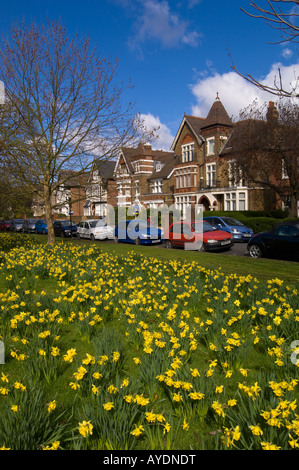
left=41, top=94, right=296, bottom=218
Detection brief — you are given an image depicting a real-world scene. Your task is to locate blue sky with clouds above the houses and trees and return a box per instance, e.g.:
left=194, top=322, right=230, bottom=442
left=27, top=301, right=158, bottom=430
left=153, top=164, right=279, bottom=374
left=0, top=0, right=299, bottom=149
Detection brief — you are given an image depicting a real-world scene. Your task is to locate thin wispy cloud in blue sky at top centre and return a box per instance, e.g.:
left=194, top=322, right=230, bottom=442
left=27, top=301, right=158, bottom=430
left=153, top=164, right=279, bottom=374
left=129, top=0, right=199, bottom=49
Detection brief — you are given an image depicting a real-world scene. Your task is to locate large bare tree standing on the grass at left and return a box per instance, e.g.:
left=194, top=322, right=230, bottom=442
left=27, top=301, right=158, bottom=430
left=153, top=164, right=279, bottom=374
left=0, top=21, right=150, bottom=244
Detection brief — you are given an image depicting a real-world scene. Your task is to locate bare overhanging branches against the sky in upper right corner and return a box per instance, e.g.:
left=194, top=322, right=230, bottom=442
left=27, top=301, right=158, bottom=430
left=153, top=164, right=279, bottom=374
left=230, top=0, right=299, bottom=98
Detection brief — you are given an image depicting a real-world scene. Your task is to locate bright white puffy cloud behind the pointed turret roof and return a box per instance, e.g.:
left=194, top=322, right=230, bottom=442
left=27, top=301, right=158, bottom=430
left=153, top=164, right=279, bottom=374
left=190, top=63, right=299, bottom=118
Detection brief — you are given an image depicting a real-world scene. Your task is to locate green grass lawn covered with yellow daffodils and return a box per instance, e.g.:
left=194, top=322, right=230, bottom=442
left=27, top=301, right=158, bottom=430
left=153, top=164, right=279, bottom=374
left=0, top=234, right=299, bottom=450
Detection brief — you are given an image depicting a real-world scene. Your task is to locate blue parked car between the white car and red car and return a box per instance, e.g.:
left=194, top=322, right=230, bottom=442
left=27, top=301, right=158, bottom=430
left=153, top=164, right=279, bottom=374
left=114, top=219, right=163, bottom=245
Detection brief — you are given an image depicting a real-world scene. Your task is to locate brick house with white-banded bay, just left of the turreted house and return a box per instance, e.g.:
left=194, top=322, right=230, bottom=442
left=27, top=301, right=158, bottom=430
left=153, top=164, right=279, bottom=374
left=113, top=142, right=174, bottom=208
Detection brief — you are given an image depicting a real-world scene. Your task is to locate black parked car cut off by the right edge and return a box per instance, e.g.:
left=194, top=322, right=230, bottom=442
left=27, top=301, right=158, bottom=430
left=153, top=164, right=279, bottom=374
left=247, top=219, right=299, bottom=260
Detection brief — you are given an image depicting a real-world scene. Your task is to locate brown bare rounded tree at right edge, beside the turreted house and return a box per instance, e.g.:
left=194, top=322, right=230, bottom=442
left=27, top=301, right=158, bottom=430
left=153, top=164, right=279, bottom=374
left=227, top=99, right=299, bottom=217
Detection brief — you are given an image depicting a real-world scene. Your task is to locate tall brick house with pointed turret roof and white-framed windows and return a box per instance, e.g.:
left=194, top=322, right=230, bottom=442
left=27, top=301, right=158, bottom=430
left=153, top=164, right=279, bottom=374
left=171, top=94, right=273, bottom=217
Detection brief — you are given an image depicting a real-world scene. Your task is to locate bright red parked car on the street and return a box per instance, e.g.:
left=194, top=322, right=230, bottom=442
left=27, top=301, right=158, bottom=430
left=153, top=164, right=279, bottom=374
left=165, top=220, right=234, bottom=251
